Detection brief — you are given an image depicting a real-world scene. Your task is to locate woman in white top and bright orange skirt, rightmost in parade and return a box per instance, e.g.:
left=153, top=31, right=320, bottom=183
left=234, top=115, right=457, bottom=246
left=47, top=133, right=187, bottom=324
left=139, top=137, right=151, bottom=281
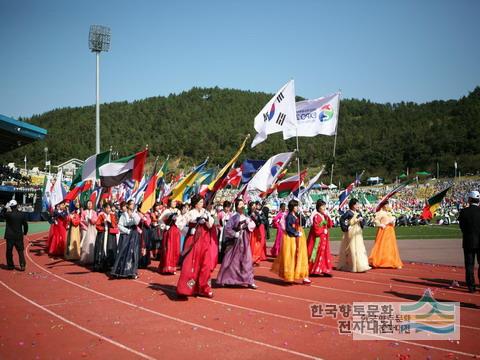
left=368, top=201, right=403, bottom=269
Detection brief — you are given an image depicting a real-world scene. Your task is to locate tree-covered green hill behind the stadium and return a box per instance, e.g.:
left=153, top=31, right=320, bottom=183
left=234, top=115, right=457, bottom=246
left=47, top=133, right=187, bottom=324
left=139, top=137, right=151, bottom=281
left=0, top=87, right=480, bottom=182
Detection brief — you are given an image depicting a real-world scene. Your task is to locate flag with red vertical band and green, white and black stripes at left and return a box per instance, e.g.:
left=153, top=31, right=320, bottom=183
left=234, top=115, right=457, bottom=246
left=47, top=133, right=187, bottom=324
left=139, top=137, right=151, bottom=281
left=98, top=150, right=148, bottom=187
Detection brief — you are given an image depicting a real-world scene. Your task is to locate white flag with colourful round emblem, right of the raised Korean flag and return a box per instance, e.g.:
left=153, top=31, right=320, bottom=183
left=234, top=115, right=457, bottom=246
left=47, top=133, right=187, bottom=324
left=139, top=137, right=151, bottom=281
left=283, top=93, right=340, bottom=139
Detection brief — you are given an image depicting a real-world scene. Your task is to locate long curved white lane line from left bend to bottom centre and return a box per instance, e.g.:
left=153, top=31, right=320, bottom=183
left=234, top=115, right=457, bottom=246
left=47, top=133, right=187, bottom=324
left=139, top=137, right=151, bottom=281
left=23, top=244, right=321, bottom=360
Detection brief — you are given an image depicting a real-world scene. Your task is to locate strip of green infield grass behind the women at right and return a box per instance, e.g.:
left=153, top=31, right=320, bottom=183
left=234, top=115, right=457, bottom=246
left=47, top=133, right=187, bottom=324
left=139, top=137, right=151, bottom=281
left=270, top=225, right=462, bottom=241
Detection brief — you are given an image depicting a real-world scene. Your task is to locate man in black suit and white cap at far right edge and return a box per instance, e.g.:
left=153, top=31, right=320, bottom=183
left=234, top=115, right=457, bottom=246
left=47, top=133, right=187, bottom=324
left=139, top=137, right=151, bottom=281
left=458, top=191, right=480, bottom=293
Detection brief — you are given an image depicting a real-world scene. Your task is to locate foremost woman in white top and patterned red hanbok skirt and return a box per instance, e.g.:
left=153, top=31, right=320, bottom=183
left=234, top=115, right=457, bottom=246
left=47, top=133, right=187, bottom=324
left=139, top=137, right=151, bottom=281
left=177, top=195, right=216, bottom=298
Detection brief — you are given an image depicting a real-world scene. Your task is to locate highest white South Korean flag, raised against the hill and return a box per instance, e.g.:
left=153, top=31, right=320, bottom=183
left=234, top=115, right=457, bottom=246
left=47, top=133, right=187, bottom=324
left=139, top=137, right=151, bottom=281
left=252, top=80, right=296, bottom=148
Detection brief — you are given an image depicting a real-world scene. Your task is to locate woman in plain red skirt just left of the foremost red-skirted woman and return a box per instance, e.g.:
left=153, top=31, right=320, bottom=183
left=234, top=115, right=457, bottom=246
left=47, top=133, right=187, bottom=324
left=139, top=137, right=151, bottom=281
left=158, top=201, right=181, bottom=275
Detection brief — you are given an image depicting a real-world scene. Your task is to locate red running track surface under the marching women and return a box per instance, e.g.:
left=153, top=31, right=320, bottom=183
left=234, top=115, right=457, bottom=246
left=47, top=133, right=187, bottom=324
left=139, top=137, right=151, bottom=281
left=0, top=234, right=480, bottom=359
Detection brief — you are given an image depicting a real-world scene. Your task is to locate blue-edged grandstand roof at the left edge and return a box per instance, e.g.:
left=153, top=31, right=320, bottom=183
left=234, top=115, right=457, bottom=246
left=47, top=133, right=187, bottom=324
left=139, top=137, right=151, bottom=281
left=0, top=114, right=47, bottom=154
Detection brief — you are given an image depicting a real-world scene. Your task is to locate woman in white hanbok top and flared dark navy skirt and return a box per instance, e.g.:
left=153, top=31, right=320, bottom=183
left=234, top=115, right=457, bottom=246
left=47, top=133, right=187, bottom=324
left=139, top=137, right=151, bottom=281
left=110, top=200, right=140, bottom=279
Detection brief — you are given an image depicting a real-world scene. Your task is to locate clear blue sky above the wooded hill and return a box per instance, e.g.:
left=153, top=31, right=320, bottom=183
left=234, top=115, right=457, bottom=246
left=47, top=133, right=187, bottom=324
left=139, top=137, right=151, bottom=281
left=0, top=0, right=480, bottom=118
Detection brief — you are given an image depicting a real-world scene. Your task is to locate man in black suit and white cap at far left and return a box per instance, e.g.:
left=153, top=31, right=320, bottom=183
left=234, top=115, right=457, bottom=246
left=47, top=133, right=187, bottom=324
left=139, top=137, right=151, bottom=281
left=4, top=200, right=28, bottom=271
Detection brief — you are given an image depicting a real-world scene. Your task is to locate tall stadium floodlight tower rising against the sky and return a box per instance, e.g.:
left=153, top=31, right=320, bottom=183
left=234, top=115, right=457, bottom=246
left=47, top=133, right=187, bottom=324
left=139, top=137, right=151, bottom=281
left=88, top=25, right=111, bottom=154
